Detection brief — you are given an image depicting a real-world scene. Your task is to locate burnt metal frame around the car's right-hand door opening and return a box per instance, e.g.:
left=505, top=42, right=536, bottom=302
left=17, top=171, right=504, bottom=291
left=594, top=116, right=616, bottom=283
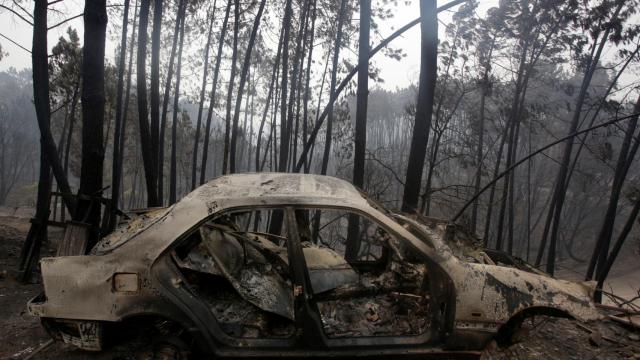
left=287, top=204, right=455, bottom=350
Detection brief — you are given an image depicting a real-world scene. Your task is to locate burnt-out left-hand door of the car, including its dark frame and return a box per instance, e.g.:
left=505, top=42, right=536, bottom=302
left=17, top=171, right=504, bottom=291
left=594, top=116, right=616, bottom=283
left=155, top=207, right=303, bottom=355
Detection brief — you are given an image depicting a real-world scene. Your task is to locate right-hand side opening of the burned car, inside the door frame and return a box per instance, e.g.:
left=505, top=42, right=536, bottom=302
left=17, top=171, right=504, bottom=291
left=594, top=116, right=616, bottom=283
left=296, top=209, right=431, bottom=338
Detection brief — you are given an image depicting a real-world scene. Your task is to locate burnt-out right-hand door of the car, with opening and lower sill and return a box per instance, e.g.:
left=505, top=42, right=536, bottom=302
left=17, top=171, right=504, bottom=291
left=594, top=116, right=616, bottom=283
left=290, top=207, right=454, bottom=348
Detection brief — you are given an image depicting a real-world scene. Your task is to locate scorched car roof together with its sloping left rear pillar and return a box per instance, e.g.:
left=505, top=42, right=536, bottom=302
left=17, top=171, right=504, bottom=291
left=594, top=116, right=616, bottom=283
left=92, top=173, right=374, bottom=259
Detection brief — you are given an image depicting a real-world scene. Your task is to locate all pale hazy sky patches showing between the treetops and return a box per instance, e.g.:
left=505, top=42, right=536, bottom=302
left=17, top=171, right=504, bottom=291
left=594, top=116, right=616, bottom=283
left=0, top=0, right=639, bottom=97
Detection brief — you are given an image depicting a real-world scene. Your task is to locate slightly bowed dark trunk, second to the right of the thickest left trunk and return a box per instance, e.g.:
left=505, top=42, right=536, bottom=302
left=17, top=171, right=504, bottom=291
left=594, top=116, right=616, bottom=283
left=136, top=0, right=161, bottom=207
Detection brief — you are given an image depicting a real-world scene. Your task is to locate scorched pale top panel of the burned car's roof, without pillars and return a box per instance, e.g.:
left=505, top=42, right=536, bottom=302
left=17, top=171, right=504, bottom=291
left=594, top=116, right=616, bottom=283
left=180, top=173, right=366, bottom=205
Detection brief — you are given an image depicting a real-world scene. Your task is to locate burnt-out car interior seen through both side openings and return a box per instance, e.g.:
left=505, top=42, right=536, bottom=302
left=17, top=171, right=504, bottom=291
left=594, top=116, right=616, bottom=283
left=172, top=208, right=431, bottom=338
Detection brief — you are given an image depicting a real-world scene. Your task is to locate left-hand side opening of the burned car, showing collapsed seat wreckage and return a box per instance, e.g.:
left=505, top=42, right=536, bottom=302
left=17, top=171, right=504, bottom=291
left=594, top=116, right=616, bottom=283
left=172, top=209, right=295, bottom=339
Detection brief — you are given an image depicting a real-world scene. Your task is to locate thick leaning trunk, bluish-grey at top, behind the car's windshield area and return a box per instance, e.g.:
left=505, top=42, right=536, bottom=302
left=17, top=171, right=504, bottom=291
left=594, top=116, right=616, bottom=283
left=402, top=0, right=438, bottom=212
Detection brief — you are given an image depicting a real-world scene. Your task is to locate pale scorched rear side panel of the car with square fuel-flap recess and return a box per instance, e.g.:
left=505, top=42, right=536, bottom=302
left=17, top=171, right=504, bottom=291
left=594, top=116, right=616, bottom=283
left=28, top=254, right=170, bottom=321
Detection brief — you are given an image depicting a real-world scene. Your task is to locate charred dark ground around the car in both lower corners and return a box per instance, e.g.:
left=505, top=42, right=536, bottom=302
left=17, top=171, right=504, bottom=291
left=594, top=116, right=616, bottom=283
left=0, top=217, right=640, bottom=360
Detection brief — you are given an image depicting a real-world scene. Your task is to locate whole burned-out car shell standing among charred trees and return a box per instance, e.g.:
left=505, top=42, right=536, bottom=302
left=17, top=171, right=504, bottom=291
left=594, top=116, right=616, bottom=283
left=28, top=173, right=600, bottom=357
